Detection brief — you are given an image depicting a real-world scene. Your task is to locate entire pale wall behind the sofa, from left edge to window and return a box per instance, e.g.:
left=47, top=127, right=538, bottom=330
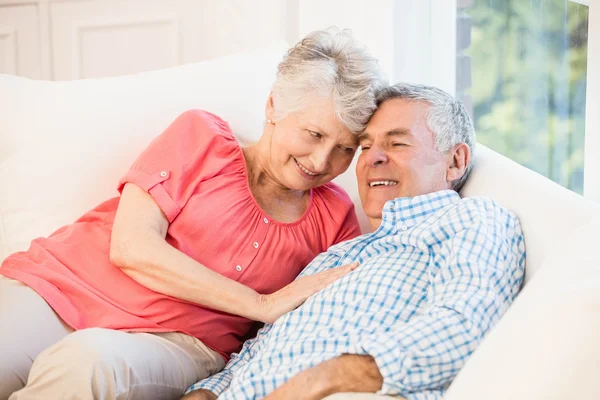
left=0, top=0, right=456, bottom=84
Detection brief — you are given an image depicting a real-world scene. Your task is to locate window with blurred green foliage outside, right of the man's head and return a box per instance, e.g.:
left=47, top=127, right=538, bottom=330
left=456, top=0, right=589, bottom=194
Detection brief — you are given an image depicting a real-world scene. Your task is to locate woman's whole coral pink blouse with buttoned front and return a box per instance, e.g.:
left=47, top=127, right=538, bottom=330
left=0, top=110, right=360, bottom=359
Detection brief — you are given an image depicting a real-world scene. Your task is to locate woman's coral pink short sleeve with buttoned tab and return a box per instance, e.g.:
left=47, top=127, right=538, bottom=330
left=118, top=110, right=237, bottom=223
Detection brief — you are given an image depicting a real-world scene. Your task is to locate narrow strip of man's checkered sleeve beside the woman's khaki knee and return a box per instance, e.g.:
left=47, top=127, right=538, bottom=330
left=185, top=324, right=272, bottom=397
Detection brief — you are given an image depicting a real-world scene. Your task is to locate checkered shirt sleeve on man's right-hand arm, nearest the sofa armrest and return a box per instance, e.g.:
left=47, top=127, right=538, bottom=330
left=361, top=209, right=525, bottom=400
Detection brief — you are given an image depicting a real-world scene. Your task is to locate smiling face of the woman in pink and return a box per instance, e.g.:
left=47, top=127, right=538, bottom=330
left=266, top=96, right=358, bottom=190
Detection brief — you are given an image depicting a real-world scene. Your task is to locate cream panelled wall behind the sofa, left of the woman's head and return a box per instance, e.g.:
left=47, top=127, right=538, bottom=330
left=0, top=0, right=291, bottom=80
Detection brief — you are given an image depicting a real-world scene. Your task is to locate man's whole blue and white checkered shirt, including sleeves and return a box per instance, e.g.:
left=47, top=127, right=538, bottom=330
left=188, top=190, right=525, bottom=400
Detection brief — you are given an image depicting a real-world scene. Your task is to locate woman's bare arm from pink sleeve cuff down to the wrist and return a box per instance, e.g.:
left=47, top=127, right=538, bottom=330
left=109, top=183, right=267, bottom=322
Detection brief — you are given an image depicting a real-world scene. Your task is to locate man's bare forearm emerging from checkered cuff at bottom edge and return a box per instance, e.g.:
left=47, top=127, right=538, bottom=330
left=265, top=354, right=406, bottom=400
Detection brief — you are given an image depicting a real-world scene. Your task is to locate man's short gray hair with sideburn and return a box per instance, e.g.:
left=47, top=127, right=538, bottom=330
left=377, top=83, right=477, bottom=192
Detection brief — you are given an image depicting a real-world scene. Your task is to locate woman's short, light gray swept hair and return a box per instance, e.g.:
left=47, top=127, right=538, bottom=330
left=272, top=27, right=387, bottom=133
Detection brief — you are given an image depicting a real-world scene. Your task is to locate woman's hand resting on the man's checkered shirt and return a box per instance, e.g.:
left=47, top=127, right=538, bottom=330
left=260, top=262, right=358, bottom=324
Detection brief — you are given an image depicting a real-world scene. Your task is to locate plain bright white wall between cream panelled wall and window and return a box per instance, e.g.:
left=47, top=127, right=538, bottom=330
left=295, top=0, right=456, bottom=93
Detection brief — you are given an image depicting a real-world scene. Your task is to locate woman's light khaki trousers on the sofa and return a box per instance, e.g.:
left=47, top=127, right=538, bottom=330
left=0, top=275, right=225, bottom=400
